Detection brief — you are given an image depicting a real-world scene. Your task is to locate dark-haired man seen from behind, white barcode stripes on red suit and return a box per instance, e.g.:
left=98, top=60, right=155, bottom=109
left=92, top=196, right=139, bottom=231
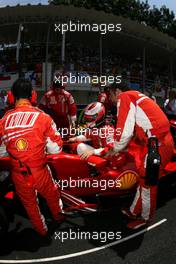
left=0, top=79, right=62, bottom=235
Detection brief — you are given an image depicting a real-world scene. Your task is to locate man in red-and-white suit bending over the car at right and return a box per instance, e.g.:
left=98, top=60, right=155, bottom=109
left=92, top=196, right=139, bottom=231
left=110, top=82, right=174, bottom=229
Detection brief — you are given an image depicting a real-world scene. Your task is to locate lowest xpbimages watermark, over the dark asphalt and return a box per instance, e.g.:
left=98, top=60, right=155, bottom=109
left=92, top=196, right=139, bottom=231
left=54, top=228, right=122, bottom=243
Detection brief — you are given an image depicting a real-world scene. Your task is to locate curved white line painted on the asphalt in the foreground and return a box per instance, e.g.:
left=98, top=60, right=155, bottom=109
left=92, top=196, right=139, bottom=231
left=0, top=218, right=167, bottom=263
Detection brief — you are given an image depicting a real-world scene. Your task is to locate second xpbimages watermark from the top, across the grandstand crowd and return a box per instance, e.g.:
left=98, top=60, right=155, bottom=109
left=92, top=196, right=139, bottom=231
left=54, top=72, right=122, bottom=86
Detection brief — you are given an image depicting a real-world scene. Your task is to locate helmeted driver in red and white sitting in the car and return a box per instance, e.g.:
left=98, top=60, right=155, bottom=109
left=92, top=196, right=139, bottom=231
left=69, top=102, right=114, bottom=159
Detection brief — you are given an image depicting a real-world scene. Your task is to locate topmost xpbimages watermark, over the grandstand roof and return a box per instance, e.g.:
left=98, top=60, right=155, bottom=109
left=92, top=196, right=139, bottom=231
left=54, top=20, right=122, bottom=35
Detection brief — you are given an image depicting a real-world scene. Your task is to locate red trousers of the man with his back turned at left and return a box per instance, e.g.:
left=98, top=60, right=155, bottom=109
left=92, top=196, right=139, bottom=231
left=12, top=166, right=61, bottom=235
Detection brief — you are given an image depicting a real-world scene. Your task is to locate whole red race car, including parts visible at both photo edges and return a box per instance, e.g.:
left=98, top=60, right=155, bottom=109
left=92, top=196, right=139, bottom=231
left=0, top=130, right=176, bottom=235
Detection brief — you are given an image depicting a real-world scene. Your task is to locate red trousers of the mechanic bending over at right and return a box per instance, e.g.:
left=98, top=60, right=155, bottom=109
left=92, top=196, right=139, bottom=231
left=130, top=133, right=174, bottom=221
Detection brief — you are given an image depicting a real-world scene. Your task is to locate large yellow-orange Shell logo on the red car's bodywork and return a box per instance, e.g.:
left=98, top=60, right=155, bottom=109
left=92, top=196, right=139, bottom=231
left=118, top=170, right=139, bottom=190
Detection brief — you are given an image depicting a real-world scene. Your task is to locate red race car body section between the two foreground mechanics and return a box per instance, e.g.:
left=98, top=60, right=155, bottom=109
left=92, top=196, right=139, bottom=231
left=48, top=140, right=139, bottom=211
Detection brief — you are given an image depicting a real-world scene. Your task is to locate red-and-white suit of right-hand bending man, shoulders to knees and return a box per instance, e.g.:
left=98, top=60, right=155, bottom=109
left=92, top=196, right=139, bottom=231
left=114, top=91, right=173, bottom=176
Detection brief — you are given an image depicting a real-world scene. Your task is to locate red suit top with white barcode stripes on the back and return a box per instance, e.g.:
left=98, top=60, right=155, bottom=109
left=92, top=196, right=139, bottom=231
left=0, top=100, right=62, bottom=167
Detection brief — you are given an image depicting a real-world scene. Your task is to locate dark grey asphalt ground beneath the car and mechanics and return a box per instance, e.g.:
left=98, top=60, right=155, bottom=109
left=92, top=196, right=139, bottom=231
left=0, top=175, right=176, bottom=264
